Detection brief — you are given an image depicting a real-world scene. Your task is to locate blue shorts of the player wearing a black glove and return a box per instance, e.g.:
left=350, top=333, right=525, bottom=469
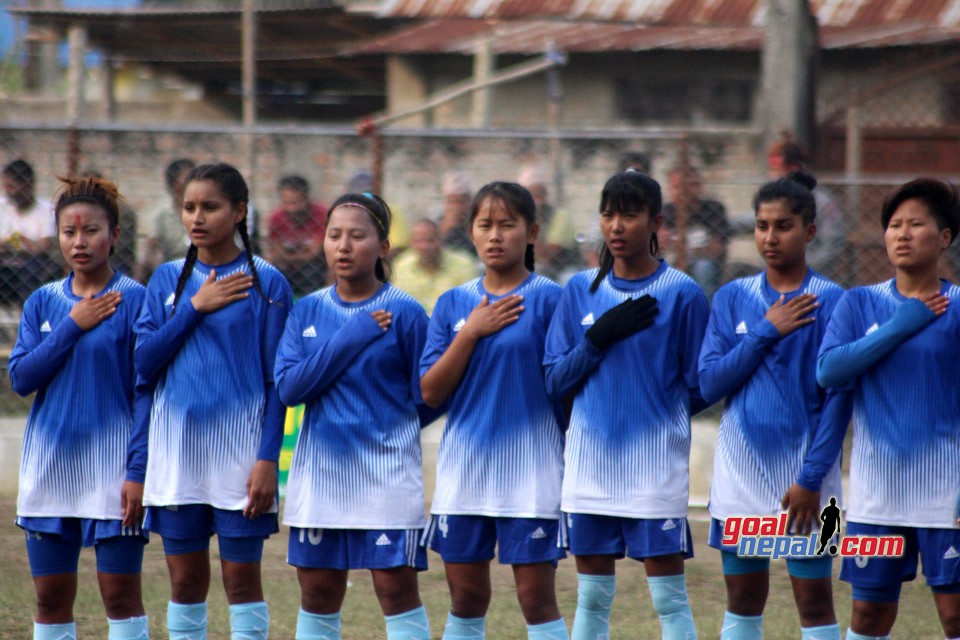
left=560, top=513, right=693, bottom=560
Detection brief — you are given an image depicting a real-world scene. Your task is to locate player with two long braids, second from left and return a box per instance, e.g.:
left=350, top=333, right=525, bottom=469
left=135, top=164, right=292, bottom=640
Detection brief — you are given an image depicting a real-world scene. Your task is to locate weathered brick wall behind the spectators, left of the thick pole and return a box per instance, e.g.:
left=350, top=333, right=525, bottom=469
left=0, top=122, right=763, bottom=250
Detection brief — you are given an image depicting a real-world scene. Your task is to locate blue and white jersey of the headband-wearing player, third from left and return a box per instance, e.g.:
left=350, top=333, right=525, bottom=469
left=276, top=284, right=427, bottom=529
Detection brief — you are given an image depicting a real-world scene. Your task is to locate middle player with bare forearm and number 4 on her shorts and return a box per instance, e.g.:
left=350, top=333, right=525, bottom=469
left=420, top=182, right=567, bottom=640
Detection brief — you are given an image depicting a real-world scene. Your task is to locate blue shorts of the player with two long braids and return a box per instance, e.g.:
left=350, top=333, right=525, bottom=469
left=144, top=504, right=280, bottom=562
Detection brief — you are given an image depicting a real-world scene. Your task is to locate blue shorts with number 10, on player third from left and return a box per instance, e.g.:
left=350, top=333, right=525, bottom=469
left=287, top=527, right=427, bottom=571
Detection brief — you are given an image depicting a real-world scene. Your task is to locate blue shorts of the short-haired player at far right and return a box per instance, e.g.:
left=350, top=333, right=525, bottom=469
left=840, top=522, right=960, bottom=602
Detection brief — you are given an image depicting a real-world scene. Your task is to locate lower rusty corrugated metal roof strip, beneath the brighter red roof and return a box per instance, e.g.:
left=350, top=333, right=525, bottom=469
left=343, top=18, right=960, bottom=55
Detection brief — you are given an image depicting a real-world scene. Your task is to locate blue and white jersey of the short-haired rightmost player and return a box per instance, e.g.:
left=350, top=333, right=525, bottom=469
left=820, top=280, right=960, bottom=528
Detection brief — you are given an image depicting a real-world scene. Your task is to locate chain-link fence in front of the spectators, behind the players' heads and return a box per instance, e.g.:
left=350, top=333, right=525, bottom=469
left=0, top=126, right=928, bottom=412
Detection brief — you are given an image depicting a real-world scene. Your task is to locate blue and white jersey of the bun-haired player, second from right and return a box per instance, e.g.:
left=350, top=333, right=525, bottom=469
left=700, top=270, right=850, bottom=520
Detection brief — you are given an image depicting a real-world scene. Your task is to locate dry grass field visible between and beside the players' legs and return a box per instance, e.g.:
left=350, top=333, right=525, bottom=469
left=0, top=494, right=943, bottom=640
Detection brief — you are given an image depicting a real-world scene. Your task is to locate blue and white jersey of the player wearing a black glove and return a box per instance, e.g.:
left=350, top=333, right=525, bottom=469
left=544, top=261, right=709, bottom=518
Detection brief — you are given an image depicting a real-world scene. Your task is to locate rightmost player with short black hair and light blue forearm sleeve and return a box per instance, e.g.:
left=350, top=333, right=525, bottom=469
left=817, top=178, right=960, bottom=640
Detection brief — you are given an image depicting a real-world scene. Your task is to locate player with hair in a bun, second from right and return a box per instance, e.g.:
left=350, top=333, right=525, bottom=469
left=700, top=173, right=851, bottom=640
